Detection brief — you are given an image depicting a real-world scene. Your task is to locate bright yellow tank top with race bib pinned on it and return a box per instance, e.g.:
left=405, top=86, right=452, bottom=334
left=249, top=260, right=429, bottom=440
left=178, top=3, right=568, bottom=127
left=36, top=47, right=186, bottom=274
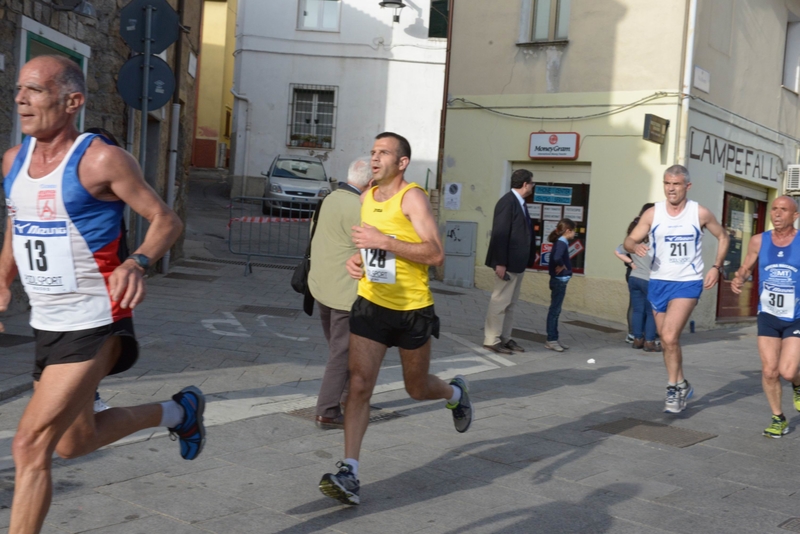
left=358, top=183, right=433, bottom=311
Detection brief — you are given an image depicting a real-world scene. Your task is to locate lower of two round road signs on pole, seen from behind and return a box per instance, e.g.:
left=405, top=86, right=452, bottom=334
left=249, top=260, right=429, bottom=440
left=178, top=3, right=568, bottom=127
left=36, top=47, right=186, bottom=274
left=117, top=54, right=175, bottom=111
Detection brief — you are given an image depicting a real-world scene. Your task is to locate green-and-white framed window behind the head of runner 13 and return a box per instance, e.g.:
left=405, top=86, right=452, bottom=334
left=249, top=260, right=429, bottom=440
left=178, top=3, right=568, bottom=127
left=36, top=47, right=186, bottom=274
left=13, top=16, right=92, bottom=143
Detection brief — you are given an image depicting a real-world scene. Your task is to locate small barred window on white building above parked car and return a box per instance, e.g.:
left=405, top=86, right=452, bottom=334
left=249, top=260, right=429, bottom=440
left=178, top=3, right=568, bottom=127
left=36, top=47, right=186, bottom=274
left=287, top=85, right=336, bottom=148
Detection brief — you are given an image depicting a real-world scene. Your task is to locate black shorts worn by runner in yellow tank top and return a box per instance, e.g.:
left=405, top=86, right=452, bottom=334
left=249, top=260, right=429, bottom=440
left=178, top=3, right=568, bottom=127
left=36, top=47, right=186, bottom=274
left=350, top=296, right=439, bottom=350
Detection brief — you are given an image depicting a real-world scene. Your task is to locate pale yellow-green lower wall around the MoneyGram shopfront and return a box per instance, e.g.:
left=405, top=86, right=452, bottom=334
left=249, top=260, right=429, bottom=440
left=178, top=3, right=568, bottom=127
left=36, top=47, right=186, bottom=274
left=440, top=91, right=679, bottom=322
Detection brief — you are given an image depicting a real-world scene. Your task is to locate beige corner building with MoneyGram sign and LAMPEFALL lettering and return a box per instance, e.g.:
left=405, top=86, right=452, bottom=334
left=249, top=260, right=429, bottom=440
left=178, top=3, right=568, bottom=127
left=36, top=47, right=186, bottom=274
left=440, top=0, right=800, bottom=328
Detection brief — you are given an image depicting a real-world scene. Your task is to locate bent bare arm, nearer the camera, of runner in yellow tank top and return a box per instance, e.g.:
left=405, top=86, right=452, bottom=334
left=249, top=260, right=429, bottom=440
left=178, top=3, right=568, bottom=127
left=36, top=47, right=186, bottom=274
left=353, top=187, right=444, bottom=265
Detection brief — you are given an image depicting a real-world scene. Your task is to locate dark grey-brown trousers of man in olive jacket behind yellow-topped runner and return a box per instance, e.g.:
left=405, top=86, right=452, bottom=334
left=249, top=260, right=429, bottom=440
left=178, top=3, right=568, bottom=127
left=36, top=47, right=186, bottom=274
left=317, top=302, right=350, bottom=418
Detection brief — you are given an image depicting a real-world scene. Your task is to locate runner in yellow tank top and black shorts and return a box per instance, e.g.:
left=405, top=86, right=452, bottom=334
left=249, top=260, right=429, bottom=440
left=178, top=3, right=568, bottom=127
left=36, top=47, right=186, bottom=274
left=319, top=132, right=472, bottom=504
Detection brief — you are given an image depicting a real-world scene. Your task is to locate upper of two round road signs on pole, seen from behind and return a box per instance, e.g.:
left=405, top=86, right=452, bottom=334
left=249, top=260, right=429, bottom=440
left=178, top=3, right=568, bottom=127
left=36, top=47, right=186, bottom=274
left=119, top=0, right=180, bottom=54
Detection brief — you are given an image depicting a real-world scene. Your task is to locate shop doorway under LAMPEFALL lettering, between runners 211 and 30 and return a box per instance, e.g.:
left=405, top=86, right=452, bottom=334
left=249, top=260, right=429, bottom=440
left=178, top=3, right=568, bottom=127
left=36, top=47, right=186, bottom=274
left=717, top=192, right=767, bottom=319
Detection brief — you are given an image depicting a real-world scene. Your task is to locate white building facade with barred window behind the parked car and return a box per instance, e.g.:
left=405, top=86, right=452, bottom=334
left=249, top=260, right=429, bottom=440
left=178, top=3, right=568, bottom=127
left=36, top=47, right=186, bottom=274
left=231, top=0, right=447, bottom=196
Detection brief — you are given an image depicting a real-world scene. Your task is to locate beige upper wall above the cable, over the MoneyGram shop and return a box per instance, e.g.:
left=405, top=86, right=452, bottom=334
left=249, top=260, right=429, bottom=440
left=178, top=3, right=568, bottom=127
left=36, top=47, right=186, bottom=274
left=450, top=0, right=688, bottom=95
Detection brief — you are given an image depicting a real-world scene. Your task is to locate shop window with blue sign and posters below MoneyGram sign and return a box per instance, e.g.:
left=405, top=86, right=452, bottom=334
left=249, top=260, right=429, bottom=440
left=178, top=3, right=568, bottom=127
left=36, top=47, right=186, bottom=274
left=525, top=182, right=589, bottom=274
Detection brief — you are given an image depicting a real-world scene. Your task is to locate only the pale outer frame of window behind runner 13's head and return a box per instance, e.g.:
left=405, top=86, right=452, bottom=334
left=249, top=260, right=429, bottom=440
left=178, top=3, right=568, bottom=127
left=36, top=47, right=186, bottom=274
left=11, top=15, right=92, bottom=146
